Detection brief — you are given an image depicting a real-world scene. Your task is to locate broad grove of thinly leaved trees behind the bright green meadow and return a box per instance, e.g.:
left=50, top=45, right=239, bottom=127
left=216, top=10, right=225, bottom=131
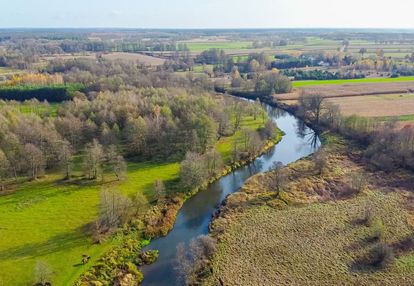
left=0, top=89, right=262, bottom=189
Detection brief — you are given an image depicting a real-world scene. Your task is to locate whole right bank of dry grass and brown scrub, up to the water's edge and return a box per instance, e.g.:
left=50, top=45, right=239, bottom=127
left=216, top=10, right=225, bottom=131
left=204, top=134, right=414, bottom=285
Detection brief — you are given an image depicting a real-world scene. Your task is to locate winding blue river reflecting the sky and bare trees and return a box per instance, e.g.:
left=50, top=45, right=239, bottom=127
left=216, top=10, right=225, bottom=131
left=142, top=105, right=320, bottom=286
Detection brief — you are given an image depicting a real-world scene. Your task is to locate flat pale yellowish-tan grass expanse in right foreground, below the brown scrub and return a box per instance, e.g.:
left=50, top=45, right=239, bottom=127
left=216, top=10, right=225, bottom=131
left=205, top=193, right=414, bottom=285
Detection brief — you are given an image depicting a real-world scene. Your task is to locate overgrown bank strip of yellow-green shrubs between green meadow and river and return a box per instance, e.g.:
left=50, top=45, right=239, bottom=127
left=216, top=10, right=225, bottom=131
left=76, top=113, right=283, bottom=285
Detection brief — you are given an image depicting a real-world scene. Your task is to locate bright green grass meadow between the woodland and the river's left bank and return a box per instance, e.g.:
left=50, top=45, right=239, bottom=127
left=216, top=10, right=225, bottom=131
left=0, top=114, right=262, bottom=286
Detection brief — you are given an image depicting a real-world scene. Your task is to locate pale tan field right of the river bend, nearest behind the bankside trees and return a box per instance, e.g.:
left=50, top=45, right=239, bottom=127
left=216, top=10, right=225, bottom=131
left=329, top=94, right=414, bottom=117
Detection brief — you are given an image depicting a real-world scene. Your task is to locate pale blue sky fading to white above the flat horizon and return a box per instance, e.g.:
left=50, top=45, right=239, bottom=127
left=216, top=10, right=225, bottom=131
left=0, top=0, right=414, bottom=29
